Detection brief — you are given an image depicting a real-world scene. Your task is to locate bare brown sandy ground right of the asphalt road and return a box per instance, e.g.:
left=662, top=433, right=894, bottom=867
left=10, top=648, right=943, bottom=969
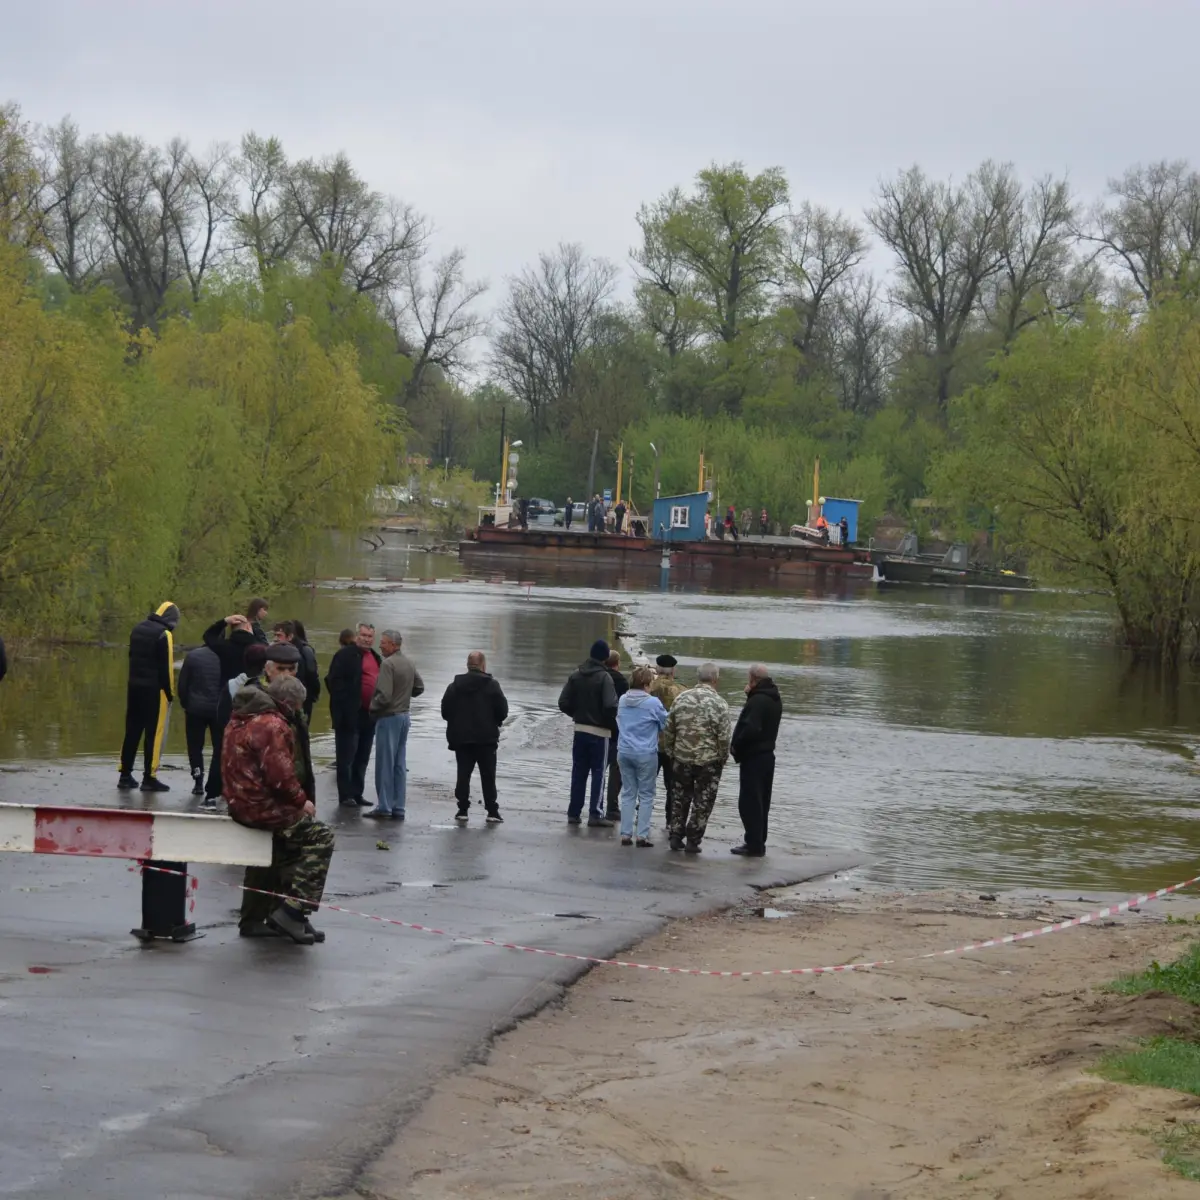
left=358, top=893, right=1200, bottom=1200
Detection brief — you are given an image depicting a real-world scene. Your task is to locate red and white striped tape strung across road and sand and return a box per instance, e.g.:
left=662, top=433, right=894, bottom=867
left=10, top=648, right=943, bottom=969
left=130, top=863, right=1200, bottom=979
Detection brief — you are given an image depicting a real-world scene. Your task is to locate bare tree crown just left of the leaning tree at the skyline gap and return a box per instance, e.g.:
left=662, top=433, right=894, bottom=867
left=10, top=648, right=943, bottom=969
left=287, top=154, right=428, bottom=296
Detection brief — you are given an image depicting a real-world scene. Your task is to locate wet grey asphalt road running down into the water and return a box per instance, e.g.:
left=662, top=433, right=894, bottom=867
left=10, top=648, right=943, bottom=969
left=0, top=762, right=856, bottom=1200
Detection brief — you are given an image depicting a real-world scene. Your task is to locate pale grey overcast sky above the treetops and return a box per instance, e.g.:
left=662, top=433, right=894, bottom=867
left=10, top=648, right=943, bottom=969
left=0, top=0, right=1200, bottom=301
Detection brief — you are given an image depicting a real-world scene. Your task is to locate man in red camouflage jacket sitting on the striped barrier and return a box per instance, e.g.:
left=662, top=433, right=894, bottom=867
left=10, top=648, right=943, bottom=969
left=221, top=677, right=334, bottom=946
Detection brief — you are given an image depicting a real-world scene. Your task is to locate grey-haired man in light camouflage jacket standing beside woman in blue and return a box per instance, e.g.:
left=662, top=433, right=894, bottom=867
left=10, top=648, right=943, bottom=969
left=664, top=662, right=732, bottom=854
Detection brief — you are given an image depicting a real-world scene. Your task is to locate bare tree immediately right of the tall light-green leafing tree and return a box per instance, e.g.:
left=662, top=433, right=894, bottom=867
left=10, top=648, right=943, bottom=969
left=784, top=202, right=866, bottom=359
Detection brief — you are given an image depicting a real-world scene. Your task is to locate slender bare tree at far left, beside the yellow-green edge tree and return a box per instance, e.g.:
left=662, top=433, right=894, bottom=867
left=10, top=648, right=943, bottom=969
left=38, top=118, right=104, bottom=292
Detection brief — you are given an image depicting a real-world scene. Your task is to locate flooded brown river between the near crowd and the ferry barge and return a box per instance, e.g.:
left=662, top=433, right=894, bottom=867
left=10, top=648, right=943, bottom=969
left=0, top=535, right=1200, bottom=892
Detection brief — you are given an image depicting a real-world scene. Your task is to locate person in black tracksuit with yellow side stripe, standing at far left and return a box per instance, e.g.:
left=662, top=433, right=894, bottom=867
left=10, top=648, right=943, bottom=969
left=116, top=600, right=179, bottom=792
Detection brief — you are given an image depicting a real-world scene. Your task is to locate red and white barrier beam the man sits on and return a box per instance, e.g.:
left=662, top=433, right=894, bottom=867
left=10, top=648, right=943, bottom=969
left=0, top=804, right=271, bottom=866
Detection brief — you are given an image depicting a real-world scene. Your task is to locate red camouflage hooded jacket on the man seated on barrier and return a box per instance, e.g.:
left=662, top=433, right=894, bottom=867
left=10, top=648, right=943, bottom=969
left=221, top=688, right=307, bottom=830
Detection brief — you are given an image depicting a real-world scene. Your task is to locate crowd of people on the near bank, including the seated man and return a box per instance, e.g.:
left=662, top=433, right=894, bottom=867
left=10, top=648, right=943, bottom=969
left=118, top=599, right=782, bottom=944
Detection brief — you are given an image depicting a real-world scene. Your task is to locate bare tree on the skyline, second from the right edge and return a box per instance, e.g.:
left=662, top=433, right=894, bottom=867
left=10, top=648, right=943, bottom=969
left=980, top=175, right=1098, bottom=347
